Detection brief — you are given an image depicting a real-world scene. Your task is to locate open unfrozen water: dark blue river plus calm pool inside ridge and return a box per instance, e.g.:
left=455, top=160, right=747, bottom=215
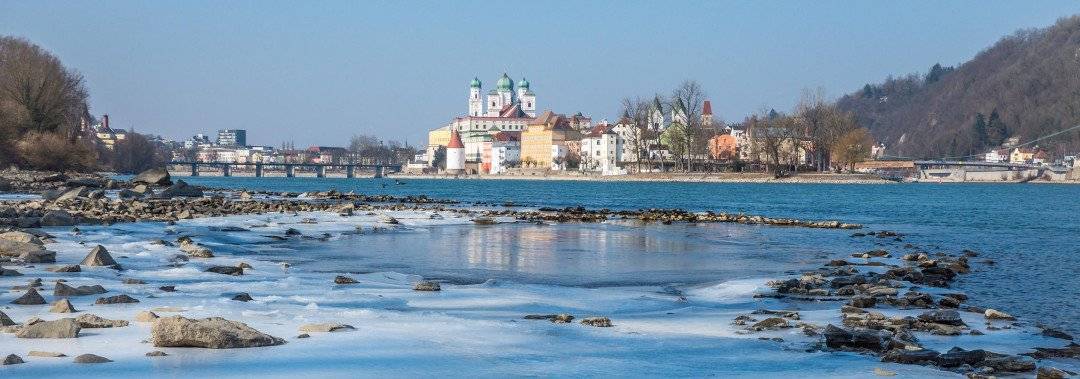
left=177, top=177, right=1080, bottom=333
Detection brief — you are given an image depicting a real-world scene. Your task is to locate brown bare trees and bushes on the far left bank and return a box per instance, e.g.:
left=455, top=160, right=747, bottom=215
left=0, top=36, right=165, bottom=172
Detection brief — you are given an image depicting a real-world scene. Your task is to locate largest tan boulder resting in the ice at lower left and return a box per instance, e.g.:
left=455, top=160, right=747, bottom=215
left=150, top=315, right=285, bottom=349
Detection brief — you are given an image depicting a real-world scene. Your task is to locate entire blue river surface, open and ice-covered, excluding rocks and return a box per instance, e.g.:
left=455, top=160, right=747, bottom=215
left=0, top=177, right=1080, bottom=378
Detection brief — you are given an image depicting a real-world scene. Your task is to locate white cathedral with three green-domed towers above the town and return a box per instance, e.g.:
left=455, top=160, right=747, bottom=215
left=469, top=72, right=537, bottom=118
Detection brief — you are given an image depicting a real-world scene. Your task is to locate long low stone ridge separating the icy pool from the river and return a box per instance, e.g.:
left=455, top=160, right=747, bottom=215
left=0, top=185, right=862, bottom=229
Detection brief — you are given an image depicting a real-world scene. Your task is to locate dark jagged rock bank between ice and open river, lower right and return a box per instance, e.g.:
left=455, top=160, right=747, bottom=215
left=732, top=231, right=1080, bottom=378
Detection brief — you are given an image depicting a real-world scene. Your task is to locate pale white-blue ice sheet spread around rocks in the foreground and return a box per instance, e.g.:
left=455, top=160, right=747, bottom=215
left=0, top=211, right=1054, bottom=378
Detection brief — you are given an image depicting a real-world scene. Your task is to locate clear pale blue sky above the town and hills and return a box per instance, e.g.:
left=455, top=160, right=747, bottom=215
left=0, top=0, right=1080, bottom=146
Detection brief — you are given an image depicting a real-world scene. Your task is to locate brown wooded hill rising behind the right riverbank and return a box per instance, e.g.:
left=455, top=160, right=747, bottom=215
left=837, top=15, right=1080, bottom=158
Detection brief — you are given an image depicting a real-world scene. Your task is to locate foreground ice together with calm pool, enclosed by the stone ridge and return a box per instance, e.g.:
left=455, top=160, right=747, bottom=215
left=0, top=212, right=1071, bottom=378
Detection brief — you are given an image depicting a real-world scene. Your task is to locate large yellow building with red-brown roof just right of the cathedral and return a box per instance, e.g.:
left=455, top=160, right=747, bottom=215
left=522, top=110, right=580, bottom=168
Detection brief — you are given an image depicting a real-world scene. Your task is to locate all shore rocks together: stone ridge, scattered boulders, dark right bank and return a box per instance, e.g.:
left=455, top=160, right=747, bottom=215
left=0, top=169, right=1080, bottom=378
